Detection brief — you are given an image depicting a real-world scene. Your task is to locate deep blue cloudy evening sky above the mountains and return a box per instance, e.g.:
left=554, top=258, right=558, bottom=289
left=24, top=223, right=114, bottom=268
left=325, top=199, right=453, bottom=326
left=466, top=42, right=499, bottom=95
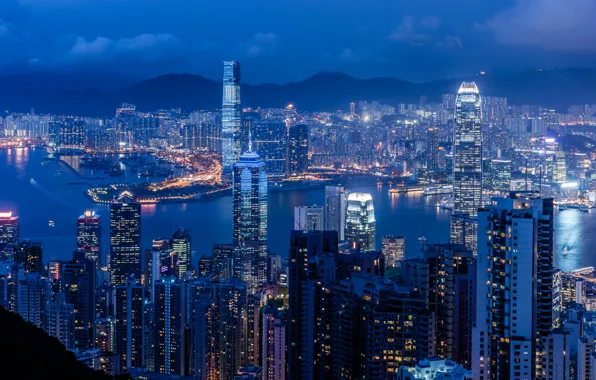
left=0, top=0, right=596, bottom=83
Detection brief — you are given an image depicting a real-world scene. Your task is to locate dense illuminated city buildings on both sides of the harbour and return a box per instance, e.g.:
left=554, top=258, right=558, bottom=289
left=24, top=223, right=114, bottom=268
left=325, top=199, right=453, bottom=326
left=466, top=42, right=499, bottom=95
left=0, top=55, right=596, bottom=380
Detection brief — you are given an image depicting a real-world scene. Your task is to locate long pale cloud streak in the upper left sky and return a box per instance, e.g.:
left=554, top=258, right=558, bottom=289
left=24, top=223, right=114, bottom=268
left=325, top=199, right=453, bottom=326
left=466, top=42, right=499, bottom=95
left=68, top=34, right=182, bottom=61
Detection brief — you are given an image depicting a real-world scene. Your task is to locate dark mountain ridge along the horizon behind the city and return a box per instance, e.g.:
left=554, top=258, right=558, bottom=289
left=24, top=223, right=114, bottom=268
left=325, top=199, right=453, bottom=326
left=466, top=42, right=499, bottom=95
left=0, top=68, right=596, bottom=116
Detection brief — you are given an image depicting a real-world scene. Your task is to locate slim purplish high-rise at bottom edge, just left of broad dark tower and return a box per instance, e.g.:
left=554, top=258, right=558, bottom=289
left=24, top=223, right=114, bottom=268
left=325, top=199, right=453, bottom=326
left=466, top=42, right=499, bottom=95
left=261, top=306, right=286, bottom=380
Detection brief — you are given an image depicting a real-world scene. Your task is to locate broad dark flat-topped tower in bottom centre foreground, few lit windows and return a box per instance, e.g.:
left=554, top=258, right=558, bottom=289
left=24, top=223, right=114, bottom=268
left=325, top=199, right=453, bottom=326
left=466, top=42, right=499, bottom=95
left=287, top=231, right=338, bottom=379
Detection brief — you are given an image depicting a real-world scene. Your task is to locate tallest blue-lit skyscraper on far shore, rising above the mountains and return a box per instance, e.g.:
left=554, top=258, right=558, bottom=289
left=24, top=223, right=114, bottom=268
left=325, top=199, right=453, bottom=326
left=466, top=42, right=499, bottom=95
left=221, top=61, right=242, bottom=175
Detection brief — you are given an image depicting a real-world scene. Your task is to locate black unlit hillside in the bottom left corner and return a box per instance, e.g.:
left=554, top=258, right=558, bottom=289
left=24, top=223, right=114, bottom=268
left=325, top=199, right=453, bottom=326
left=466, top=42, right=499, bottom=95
left=0, top=306, right=132, bottom=380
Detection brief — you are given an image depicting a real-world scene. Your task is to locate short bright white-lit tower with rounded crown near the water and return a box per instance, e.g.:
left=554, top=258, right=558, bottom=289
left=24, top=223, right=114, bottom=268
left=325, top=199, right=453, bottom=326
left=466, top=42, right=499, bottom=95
left=346, top=193, right=376, bottom=252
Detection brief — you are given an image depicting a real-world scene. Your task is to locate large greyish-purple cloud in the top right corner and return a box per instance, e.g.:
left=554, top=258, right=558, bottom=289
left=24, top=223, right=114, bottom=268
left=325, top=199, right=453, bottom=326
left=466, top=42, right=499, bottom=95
left=478, top=0, right=596, bottom=52
